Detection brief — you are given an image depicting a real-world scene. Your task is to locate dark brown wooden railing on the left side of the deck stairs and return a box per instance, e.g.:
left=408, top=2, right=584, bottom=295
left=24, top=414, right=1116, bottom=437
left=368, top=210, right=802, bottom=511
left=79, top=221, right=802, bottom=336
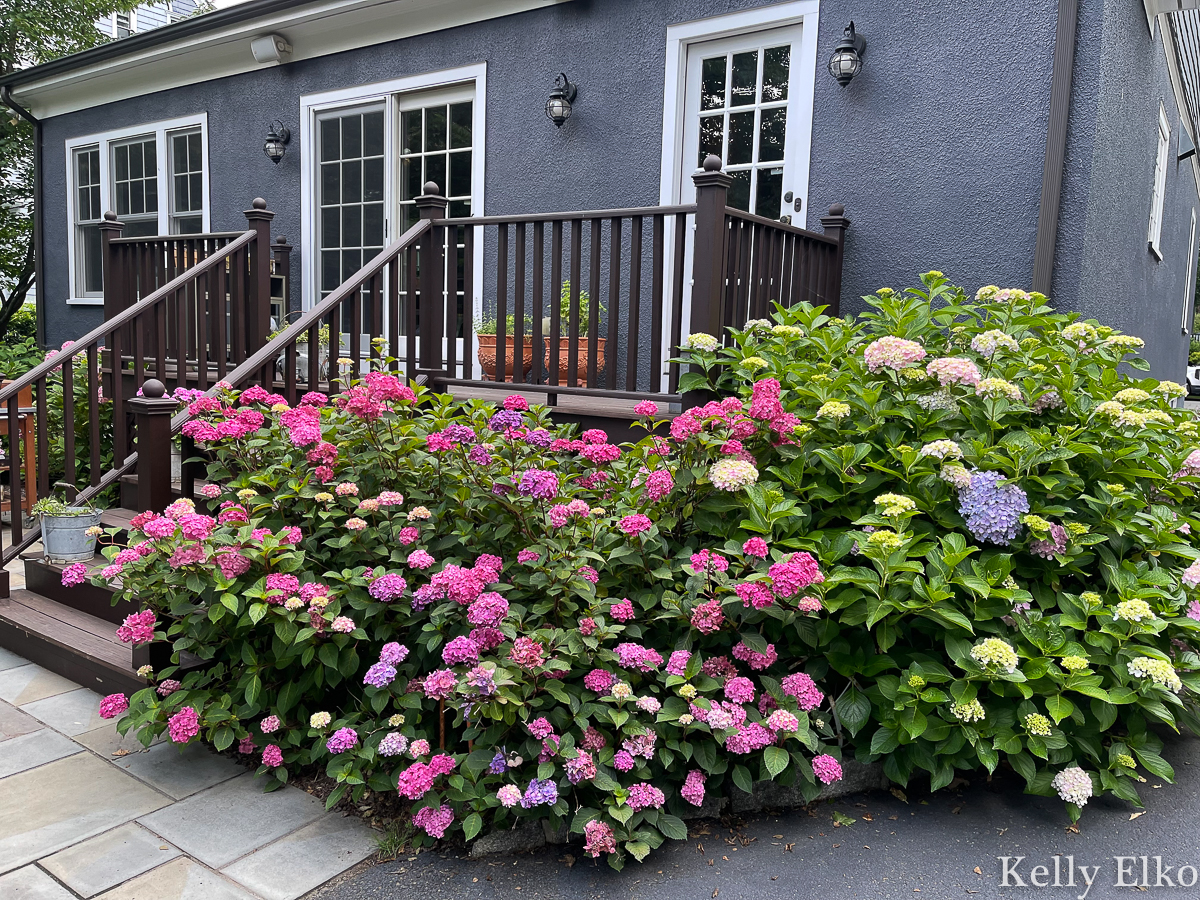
left=0, top=199, right=272, bottom=564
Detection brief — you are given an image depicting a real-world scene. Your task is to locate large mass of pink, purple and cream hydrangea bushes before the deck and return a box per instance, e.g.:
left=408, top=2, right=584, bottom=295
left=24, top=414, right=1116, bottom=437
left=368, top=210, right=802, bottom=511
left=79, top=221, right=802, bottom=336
left=93, top=272, right=1200, bottom=866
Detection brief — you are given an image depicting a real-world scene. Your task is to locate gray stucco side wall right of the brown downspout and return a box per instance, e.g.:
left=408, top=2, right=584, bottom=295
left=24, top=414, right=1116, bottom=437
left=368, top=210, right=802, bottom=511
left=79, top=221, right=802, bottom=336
left=1054, top=0, right=1198, bottom=380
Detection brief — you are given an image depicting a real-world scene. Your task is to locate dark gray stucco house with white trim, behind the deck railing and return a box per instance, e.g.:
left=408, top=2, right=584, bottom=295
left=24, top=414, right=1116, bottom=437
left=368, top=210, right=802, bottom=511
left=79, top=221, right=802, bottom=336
left=7, top=0, right=1200, bottom=379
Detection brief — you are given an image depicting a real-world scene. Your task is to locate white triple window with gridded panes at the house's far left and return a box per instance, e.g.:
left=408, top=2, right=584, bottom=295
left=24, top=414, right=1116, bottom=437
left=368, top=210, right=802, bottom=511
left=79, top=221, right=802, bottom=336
left=66, top=114, right=209, bottom=304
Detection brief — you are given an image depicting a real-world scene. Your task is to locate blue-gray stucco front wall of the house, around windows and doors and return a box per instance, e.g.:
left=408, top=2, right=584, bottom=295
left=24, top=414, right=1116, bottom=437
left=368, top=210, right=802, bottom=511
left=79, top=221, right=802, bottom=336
left=37, top=0, right=1187, bottom=376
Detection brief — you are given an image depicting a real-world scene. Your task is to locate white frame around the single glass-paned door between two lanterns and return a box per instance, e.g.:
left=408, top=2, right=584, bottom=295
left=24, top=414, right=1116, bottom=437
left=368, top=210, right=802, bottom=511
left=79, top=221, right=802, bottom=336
left=652, top=0, right=821, bottom=391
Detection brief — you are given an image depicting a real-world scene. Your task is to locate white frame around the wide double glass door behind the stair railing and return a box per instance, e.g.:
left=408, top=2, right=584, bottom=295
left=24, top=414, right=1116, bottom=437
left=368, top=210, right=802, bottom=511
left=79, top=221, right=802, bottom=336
left=300, top=62, right=487, bottom=321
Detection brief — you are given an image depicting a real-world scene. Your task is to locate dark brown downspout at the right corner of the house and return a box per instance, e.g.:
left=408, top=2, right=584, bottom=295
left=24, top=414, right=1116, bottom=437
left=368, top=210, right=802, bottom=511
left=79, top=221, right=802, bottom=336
left=1032, top=0, right=1079, bottom=296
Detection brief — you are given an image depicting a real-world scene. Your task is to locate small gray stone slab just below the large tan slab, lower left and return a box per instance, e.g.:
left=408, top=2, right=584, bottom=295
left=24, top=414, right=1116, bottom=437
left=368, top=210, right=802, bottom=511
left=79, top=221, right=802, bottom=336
left=38, top=822, right=179, bottom=898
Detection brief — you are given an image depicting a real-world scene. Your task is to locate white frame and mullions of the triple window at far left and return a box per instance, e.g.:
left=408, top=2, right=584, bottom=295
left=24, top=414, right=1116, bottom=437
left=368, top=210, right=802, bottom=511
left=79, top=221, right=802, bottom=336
left=65, top=113, right=212, bottom=306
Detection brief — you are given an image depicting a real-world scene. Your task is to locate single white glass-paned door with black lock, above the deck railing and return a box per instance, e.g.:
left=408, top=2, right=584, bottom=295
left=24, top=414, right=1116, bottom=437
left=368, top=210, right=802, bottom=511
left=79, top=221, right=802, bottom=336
left=679, top=25, right=811, bottom=222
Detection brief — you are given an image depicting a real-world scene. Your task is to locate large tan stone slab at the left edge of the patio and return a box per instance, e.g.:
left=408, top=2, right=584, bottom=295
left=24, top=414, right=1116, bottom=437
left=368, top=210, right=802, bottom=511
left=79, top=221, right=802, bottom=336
left=0, top=754, right=169, bottom=872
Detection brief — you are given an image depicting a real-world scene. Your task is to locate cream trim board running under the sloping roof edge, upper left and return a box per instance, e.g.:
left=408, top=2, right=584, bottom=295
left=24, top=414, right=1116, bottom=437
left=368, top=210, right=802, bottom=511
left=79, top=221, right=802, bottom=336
left=13, top=0, right=574, bottom=118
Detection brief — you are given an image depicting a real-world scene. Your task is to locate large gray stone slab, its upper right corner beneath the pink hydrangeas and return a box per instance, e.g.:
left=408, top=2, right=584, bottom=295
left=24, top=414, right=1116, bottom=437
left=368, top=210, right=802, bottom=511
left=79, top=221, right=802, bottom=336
left=139, top=772, right=325, bottom=869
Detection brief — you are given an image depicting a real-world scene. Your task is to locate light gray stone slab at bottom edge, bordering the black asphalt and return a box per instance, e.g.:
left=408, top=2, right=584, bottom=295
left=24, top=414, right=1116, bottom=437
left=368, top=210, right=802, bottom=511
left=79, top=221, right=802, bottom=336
left=222, top=814, right=377, bottom=900
